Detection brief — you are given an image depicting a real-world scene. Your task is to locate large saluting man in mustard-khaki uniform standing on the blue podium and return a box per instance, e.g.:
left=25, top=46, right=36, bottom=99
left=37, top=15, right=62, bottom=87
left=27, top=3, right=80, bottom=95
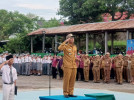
left=58, top=34, right=77, bottom=98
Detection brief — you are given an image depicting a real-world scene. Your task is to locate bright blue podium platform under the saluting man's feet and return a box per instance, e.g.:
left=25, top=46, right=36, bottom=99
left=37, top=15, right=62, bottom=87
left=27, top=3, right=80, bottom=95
left=39, top=95, right=96, bottom=100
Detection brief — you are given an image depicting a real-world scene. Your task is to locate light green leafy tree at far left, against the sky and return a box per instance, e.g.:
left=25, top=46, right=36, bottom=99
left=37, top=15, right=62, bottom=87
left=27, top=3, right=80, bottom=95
left=0, top=10, right=38, bottom=40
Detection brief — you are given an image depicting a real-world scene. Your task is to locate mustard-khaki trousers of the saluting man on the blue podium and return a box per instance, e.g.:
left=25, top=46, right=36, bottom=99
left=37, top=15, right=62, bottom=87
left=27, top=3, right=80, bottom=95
left=63, top=67, right=77, bottom=95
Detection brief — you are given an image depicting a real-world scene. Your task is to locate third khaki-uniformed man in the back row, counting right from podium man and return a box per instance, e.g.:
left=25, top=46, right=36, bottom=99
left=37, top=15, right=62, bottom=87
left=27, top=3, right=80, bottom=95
left=104, top=52, right=112, bottom=83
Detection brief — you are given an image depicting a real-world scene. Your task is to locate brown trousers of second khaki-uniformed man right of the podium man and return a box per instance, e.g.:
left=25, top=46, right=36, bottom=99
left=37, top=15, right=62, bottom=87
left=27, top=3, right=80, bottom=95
left=93, top=66, right=100, bottom=82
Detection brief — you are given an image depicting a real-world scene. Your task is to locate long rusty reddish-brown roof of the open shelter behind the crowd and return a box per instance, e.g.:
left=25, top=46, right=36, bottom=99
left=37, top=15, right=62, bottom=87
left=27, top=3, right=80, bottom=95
left=28, top=19, right=134, bottom=35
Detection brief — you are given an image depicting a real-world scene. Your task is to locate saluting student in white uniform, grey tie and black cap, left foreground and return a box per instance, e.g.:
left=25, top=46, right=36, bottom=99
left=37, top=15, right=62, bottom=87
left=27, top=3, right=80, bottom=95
left=0, top=55, right=17, bottom=100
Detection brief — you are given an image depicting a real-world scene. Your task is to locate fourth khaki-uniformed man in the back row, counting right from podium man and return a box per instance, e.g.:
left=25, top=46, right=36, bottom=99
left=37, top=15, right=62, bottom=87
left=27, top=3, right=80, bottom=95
left=116, top=54, right=123, bottom=84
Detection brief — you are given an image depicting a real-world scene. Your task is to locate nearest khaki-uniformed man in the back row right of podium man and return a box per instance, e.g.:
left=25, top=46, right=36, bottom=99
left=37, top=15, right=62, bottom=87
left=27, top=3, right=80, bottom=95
left=84, top=54, right=90, bottom=82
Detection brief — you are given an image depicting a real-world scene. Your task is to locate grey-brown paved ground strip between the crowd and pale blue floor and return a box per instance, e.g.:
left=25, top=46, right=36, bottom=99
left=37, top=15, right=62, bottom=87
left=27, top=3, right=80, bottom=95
left=0, top=75, right=134, bottom=93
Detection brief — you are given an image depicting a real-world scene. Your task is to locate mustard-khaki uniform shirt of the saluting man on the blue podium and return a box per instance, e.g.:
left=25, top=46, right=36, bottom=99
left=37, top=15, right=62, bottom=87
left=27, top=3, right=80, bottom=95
left=58, top=42, right=77, bottom=68
